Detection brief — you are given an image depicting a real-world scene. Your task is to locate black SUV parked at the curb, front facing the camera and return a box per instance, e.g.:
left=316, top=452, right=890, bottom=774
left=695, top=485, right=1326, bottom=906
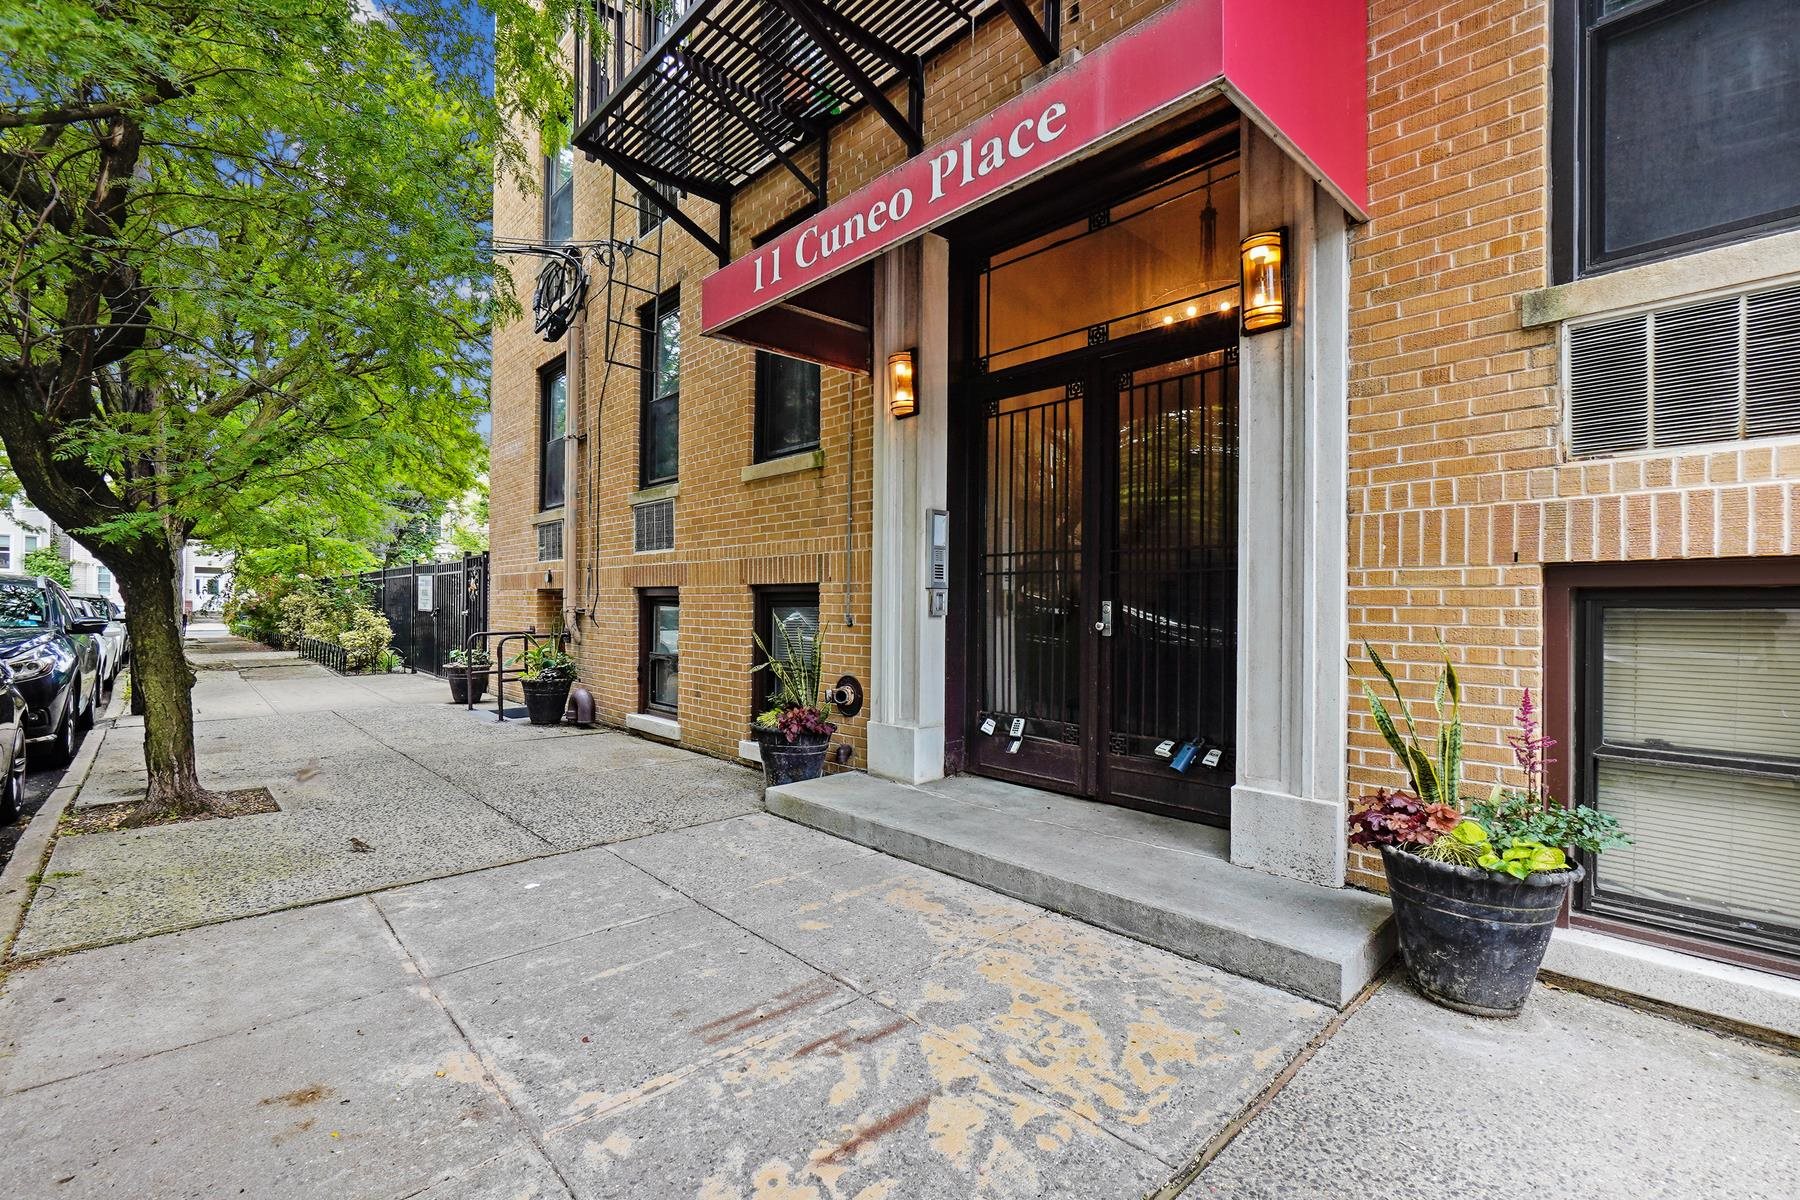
left=0, top=574, right=106, bottom=763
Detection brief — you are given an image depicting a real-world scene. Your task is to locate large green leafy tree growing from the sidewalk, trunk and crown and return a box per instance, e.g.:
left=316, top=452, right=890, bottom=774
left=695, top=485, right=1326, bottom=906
left=0, top=0, right=574, bottom=811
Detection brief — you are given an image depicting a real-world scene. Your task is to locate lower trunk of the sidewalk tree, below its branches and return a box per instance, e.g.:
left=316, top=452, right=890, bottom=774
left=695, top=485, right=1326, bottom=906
left=115, top=545, right=216, bottom=815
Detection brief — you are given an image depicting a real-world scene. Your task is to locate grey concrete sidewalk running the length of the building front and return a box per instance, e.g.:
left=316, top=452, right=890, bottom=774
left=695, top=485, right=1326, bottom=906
left=0, top=629, right=1800, bottom=1200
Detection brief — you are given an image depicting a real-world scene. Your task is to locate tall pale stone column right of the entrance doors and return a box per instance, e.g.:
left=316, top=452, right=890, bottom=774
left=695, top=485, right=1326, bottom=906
left=1231, top=122, right=1350, bottom=887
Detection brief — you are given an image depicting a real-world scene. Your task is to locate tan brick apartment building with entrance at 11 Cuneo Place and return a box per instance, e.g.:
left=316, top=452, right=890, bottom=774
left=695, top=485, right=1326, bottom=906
left=491, top=0, right=1800, bottom=993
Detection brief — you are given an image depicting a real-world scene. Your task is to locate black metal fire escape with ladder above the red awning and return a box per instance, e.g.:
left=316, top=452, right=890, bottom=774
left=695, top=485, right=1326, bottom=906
left=495, top=0, right=1062, bottom=613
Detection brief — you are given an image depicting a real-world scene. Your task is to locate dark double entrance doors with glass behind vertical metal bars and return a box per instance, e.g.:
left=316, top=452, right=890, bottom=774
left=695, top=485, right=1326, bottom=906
left=967, top=340, right=1237, bottom=822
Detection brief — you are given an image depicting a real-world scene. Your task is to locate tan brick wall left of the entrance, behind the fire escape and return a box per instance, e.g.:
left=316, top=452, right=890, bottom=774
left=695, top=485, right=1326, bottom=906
left=490, top=0, right=1195, bottom=766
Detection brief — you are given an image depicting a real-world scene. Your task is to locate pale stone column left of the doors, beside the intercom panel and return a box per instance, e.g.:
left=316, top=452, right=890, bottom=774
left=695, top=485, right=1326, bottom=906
left=868, top=236, right=950, bottom=783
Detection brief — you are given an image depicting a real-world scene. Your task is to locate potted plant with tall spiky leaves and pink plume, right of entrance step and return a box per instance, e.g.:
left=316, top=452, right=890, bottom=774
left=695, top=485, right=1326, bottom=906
left=1350, top=642, right=1629, bottom=1016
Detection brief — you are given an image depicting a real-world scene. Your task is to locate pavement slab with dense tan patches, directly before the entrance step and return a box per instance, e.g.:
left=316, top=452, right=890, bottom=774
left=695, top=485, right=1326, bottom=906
left=877, top=916, right=1332, bottom=1162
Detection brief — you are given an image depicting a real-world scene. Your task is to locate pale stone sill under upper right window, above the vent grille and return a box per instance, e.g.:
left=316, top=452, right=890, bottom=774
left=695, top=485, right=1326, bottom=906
left=1519, top=230, right=1800, bottom=329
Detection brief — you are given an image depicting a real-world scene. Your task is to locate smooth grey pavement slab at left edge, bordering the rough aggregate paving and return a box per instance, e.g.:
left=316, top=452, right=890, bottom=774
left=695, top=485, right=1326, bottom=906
left=0, top=900, right=405, bottom=1092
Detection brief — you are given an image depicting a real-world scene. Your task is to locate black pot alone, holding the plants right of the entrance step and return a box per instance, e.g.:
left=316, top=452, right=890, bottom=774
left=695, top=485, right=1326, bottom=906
left=1381, top=846, right=1586, bottom=1016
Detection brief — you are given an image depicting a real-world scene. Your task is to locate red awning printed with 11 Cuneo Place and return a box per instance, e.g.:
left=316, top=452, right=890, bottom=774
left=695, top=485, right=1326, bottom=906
left=700, top=0, right=1368, bottom=371
